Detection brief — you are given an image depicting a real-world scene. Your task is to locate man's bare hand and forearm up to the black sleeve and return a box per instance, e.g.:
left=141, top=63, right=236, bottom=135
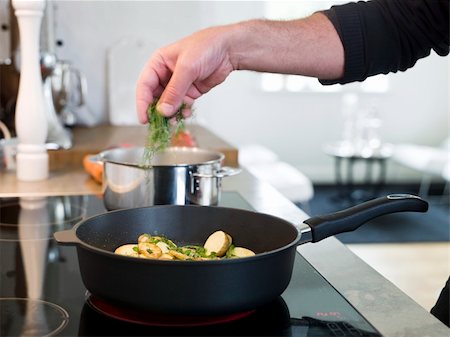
left=136, top=13, right=344, bottom=123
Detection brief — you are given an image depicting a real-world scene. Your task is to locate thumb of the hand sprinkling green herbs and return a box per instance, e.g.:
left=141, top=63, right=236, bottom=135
left=157, top=65, right=194, bottom=117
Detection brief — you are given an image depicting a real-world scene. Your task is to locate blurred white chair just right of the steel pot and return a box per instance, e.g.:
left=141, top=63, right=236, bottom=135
left=239, top=144, right=314, bottom=212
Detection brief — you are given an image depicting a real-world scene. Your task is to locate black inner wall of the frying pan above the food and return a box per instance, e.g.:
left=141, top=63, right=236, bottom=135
left=76, top=205, right=298, bottom=253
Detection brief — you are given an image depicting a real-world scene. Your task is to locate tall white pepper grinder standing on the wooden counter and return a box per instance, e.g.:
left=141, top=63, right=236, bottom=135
left=12, top=0, right=48, bottom=181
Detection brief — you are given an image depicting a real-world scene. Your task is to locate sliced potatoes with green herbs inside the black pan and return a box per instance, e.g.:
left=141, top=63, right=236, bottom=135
left=114, top=231, right=255, bottom=261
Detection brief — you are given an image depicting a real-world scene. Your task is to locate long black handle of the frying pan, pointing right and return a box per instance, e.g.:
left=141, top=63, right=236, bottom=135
left=304, top=194, right=428, bottom=242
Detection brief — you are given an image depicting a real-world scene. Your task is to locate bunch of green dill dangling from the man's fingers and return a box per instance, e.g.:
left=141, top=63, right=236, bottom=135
left=142, top=100, right=185, bottom=166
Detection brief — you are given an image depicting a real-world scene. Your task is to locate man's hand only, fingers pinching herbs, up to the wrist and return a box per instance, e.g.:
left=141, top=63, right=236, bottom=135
left=136, top=27, right=234, bottom=123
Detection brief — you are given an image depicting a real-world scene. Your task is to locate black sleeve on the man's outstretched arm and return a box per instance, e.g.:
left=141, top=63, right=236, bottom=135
left=321, top=0, right=450, bottom=84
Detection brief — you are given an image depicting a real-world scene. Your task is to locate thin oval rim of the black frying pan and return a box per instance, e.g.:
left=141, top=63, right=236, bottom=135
left=72, top=205, right=302, bottom=266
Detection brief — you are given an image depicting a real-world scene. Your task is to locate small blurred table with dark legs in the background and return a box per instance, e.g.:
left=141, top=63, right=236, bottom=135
left=323, top=141, right=393, bottom=203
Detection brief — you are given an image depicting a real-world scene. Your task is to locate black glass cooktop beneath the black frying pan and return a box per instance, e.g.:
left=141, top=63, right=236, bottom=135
left=0, top=192, right=380, bottom=336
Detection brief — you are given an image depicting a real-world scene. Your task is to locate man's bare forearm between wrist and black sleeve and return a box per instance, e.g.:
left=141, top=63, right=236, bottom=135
left=228, top=13, right=344, bottom=80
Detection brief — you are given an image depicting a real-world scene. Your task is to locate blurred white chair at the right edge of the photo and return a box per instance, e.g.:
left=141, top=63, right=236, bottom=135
left=392, top=137, right=450, bottom=197
